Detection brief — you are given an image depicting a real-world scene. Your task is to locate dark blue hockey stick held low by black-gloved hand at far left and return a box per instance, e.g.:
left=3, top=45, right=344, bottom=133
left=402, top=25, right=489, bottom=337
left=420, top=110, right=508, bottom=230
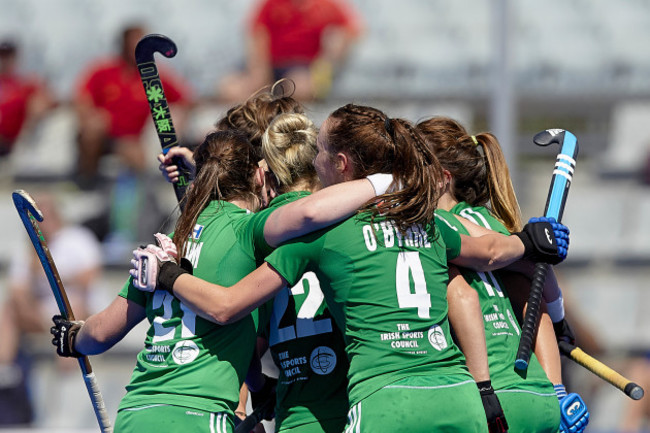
left=11, top=190, right=113, bottom=433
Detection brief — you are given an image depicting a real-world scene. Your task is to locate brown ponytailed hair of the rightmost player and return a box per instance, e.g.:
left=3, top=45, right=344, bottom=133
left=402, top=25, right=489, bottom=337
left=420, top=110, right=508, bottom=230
left=417, top=116, right=522, bottom=232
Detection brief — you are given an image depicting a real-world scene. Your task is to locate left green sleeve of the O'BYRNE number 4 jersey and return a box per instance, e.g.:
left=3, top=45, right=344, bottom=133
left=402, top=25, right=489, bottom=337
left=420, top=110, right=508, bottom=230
left=266, top=231, right=325, bottom=286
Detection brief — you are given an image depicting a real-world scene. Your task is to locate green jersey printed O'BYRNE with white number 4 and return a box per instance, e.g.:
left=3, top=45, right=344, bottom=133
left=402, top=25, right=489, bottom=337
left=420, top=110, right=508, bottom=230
left=266, top=214, right=471, bottom=405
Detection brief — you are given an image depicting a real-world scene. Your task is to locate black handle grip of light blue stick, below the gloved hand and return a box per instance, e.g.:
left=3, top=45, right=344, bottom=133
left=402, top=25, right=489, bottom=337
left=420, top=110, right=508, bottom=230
left=515, top=263, right=548, bottom=370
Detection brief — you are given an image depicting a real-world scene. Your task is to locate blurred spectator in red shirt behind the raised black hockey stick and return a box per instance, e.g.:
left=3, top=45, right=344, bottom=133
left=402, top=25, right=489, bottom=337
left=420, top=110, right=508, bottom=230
left=74, top=25, right=192, bottom=186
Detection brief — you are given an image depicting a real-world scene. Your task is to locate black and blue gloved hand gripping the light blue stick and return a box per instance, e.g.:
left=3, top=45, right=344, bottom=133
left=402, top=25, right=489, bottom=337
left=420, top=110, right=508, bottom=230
left=513, top=217, right=569, bottom=265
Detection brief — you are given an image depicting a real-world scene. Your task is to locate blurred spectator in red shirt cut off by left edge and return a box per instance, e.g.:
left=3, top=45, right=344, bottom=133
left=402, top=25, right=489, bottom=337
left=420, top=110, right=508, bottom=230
left=0, top=40, right=55, bottom=157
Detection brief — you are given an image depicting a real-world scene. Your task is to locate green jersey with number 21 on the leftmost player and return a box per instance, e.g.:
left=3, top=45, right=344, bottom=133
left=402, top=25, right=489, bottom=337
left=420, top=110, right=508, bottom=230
left=119, top=201, right=268, bottom=413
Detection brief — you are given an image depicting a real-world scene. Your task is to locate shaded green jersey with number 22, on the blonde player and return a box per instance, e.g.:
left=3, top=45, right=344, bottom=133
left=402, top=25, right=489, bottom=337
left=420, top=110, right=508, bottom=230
left=239, top=191, right=348, bottom=430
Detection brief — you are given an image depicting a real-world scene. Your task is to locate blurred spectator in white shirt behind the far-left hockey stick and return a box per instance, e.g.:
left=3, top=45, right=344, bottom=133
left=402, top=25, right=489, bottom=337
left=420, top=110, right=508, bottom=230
left=0, top=194, right=102, bottom=426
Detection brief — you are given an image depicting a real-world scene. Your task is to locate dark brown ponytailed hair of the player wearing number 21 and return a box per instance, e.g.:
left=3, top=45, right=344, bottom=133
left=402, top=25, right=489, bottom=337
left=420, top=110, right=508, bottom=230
left=174, top=131, right=260, bottom=257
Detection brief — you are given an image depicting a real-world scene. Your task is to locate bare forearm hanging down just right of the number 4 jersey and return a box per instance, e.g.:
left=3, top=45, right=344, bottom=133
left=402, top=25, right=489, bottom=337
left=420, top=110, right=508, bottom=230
left=447, top=266, right=490, bottom=382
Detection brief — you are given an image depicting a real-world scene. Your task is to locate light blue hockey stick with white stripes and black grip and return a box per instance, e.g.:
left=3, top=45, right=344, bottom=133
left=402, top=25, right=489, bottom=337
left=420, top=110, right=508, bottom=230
left=515, top=129, right=578, bottom=370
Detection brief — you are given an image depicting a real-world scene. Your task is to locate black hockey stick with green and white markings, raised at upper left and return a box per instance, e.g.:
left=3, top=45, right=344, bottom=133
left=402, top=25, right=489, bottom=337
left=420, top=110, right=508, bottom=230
left=135, top=34, right=189, bottom=209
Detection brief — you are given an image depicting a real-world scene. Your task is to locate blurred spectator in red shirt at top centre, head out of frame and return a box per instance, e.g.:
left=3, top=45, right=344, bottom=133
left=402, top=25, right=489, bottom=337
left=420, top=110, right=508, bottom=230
left=217, top=0, right=362, bottom=102
